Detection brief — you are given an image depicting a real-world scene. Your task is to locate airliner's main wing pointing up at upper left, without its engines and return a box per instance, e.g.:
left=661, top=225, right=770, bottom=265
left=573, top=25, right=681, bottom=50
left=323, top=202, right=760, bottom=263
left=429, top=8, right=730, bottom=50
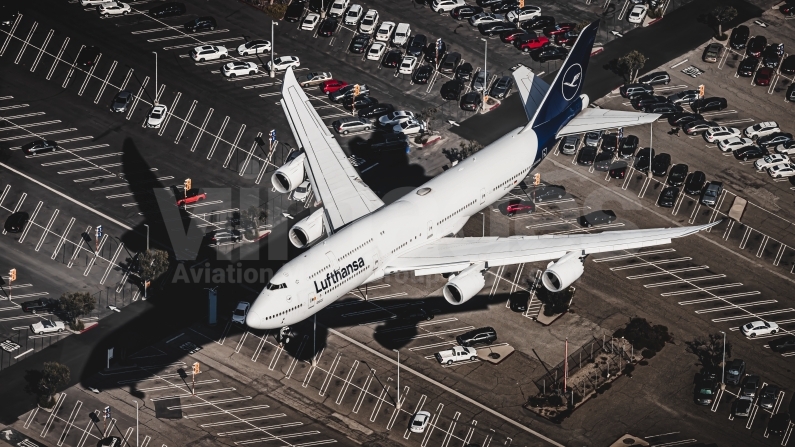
left=282, top=68, right=384, bottom=235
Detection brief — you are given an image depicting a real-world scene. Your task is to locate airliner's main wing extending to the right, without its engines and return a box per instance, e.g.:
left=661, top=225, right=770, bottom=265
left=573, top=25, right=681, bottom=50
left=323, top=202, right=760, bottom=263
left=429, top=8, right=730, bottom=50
left=384, top=221, right=720, bottom=276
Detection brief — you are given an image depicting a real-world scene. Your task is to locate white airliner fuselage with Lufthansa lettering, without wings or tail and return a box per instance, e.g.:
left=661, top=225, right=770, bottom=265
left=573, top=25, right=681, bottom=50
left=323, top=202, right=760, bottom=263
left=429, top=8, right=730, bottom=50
left=246, top=127, right=545, bottom=329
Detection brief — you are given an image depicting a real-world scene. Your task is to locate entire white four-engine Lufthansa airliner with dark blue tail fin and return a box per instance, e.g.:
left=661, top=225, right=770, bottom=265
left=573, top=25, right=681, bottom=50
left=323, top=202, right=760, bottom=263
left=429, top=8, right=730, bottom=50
left=246, top=22, right=714, bottom=329
